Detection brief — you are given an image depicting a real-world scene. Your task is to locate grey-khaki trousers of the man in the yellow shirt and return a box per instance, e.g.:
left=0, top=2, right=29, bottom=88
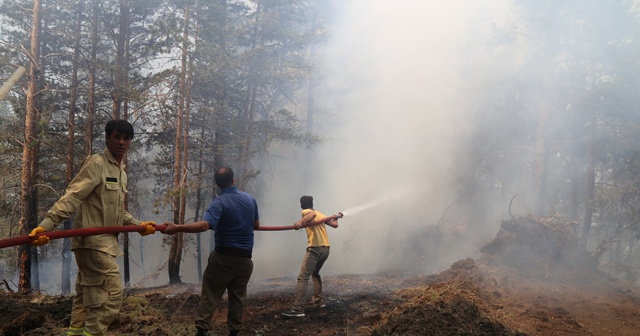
left=293, top=246, right=329, bottom=312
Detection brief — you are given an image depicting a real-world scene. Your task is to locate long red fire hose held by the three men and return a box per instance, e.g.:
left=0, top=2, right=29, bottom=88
left=0, top=212, right=342, bottom=249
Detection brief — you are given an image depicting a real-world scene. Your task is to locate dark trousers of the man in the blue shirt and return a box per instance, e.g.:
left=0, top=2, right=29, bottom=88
left=196, top=252, right=253, bottom=330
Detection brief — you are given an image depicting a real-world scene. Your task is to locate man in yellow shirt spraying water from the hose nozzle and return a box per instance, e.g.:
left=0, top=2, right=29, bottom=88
left=282, top=196, right=338, bottom=317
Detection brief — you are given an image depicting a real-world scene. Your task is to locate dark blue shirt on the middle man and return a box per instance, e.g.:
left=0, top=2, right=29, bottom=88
left=203, top=186, right=259, bottom=252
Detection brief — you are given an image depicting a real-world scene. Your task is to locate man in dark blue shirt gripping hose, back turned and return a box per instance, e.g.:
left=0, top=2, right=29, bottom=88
left=162, top=167, right=260, bottom=336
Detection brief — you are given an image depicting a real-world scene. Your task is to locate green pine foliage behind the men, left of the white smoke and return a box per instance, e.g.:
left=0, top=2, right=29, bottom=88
left=0, top=0, right=338, bottom=286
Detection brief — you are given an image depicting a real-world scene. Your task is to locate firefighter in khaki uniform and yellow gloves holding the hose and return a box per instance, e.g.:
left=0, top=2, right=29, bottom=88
left=29, top=120, right=155, bottom=336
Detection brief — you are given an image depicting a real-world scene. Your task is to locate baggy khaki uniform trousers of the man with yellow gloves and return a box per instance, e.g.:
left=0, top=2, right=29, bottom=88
left=67, top=249, right=123, bottom=336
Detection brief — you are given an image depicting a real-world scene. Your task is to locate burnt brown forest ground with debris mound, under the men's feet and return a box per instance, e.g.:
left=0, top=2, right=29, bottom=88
left=0, top=218, right=640, bottom=336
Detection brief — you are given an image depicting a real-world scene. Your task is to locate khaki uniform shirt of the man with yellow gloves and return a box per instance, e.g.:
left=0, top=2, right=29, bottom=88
left=40, top=148, right=140, bottom=256
